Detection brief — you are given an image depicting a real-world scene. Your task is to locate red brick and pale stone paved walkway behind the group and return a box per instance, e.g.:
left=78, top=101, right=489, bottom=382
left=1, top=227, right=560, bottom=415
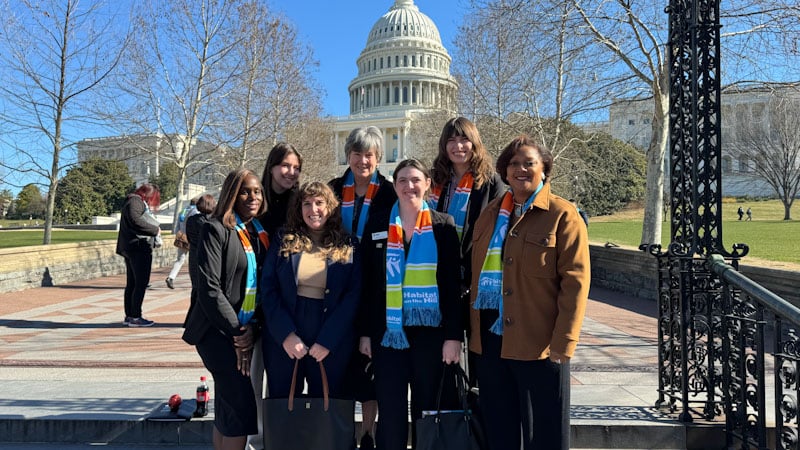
left=0, top=268, right=672, bottom=446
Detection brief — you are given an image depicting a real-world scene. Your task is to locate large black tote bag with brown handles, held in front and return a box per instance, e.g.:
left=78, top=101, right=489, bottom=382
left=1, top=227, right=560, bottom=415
left=263, top=360, right=356, bottom=450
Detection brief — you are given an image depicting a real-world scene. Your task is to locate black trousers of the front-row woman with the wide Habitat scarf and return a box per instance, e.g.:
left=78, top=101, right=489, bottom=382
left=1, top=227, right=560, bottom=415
left=372, top=327, right=459, bottom=450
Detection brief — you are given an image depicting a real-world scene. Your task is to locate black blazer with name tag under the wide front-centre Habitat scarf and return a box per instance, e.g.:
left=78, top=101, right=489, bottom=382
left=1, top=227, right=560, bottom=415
left=356, top=210, right=464, bottom=344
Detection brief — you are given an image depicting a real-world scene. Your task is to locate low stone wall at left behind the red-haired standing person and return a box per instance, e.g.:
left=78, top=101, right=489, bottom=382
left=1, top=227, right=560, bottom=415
left=0, top=239, right=176, bottom=292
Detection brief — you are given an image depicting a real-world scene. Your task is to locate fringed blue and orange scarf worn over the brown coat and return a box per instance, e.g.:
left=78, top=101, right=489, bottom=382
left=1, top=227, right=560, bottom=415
left=473, top=182, right=543, bottom=336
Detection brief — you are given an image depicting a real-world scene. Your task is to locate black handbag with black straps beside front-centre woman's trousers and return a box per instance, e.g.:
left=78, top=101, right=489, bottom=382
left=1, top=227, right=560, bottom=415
left=416, top=364, right=489, bottom=450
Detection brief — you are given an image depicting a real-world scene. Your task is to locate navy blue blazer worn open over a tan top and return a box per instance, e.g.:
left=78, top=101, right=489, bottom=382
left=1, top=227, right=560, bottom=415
left=258, top=235, right=361, bottom=351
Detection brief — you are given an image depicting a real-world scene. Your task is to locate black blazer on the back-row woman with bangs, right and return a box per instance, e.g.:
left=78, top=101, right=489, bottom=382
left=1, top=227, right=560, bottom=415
left=436, top=173, right=508, bottom=293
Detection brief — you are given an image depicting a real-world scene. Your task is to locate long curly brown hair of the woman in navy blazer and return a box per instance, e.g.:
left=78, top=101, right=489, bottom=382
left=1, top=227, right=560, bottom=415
left=281, top=181, right=353, bottom=262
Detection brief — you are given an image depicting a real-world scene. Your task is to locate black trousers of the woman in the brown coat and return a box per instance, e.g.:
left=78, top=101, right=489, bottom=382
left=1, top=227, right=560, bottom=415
left=478, top=330, right=570, bottom=450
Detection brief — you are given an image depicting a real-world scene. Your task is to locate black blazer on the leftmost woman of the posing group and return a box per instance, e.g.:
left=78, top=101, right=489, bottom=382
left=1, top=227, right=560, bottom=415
left=183, top=218, right=263, bottom=345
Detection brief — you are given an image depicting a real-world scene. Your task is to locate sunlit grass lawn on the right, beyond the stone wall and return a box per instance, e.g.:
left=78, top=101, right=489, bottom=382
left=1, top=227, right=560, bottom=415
left=589, top=200, right=800, bottom=263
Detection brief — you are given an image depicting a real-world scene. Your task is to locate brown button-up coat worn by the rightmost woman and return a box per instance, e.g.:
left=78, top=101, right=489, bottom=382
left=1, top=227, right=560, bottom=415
left=469, top=183, right=591, bottom=361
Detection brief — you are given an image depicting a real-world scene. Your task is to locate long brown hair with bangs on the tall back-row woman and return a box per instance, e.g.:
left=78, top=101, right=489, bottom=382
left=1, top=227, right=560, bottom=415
left=432, top=117, right=494, bottom=188
